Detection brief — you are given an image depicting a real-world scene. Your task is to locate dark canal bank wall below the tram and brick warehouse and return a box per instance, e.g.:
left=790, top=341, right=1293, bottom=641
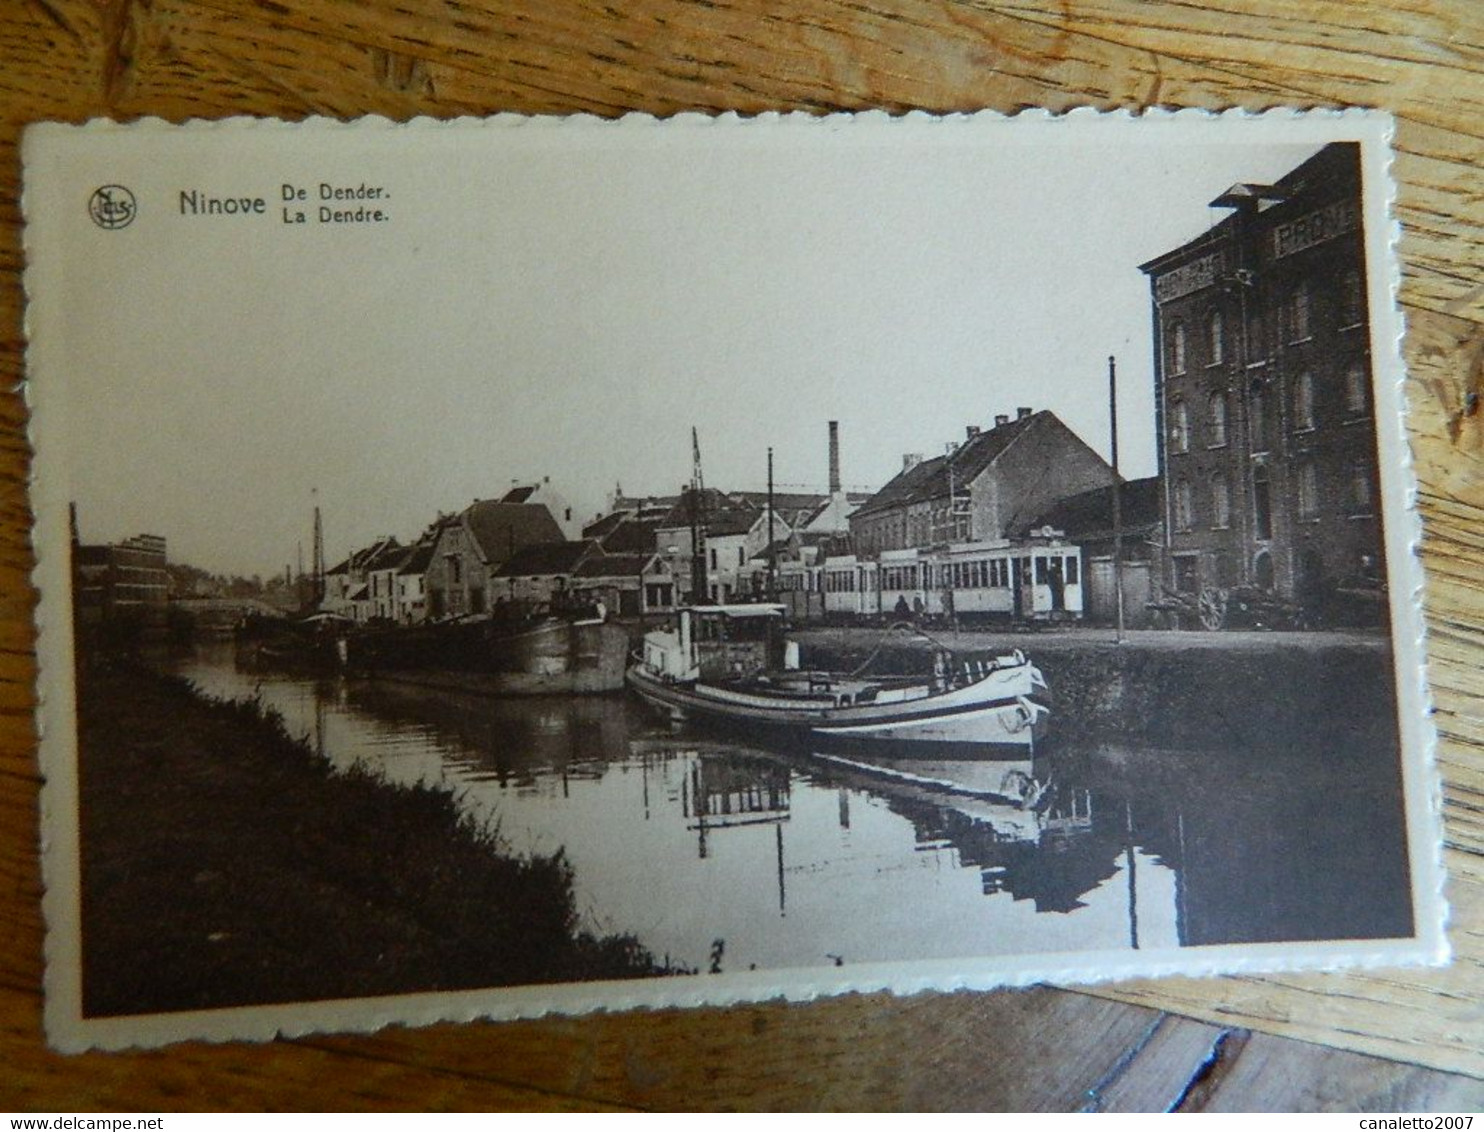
left=794, top=628, right=1396, bottom=749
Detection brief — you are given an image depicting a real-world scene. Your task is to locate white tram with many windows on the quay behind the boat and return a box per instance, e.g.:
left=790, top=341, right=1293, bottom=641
left=800, top=539, right=1086, bottom=622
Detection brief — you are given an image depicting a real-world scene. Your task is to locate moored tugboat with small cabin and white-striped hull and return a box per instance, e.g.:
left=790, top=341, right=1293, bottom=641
left=628, top=604, right=1049, bottom=758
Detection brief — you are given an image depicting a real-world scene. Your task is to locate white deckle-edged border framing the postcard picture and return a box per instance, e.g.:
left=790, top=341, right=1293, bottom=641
left=22, top=110, right=1448, bottom=1052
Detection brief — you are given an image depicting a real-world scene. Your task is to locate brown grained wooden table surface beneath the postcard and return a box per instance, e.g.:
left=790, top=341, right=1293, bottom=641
left=0, top=0, right=1484, bottom=1111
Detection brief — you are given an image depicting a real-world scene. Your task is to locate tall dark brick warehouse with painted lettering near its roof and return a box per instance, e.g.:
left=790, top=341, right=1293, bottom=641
left=1140, top=144, right=1385, bottom=620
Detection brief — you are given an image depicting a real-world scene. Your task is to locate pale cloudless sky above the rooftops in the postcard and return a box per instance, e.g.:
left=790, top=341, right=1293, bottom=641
left=40, top=123, right=1318, bottom=574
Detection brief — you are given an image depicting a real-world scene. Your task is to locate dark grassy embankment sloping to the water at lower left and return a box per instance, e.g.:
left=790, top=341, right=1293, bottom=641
left=79, top=671, right=662, bottom=1016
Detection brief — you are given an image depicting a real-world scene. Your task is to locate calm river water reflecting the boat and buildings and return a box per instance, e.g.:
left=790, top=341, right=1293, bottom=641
left=175, top=647, right=1411, bottom=970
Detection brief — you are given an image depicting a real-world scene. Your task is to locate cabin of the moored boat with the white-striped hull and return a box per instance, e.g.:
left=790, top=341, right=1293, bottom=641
left=644, top=604, right=798, bottom=682
